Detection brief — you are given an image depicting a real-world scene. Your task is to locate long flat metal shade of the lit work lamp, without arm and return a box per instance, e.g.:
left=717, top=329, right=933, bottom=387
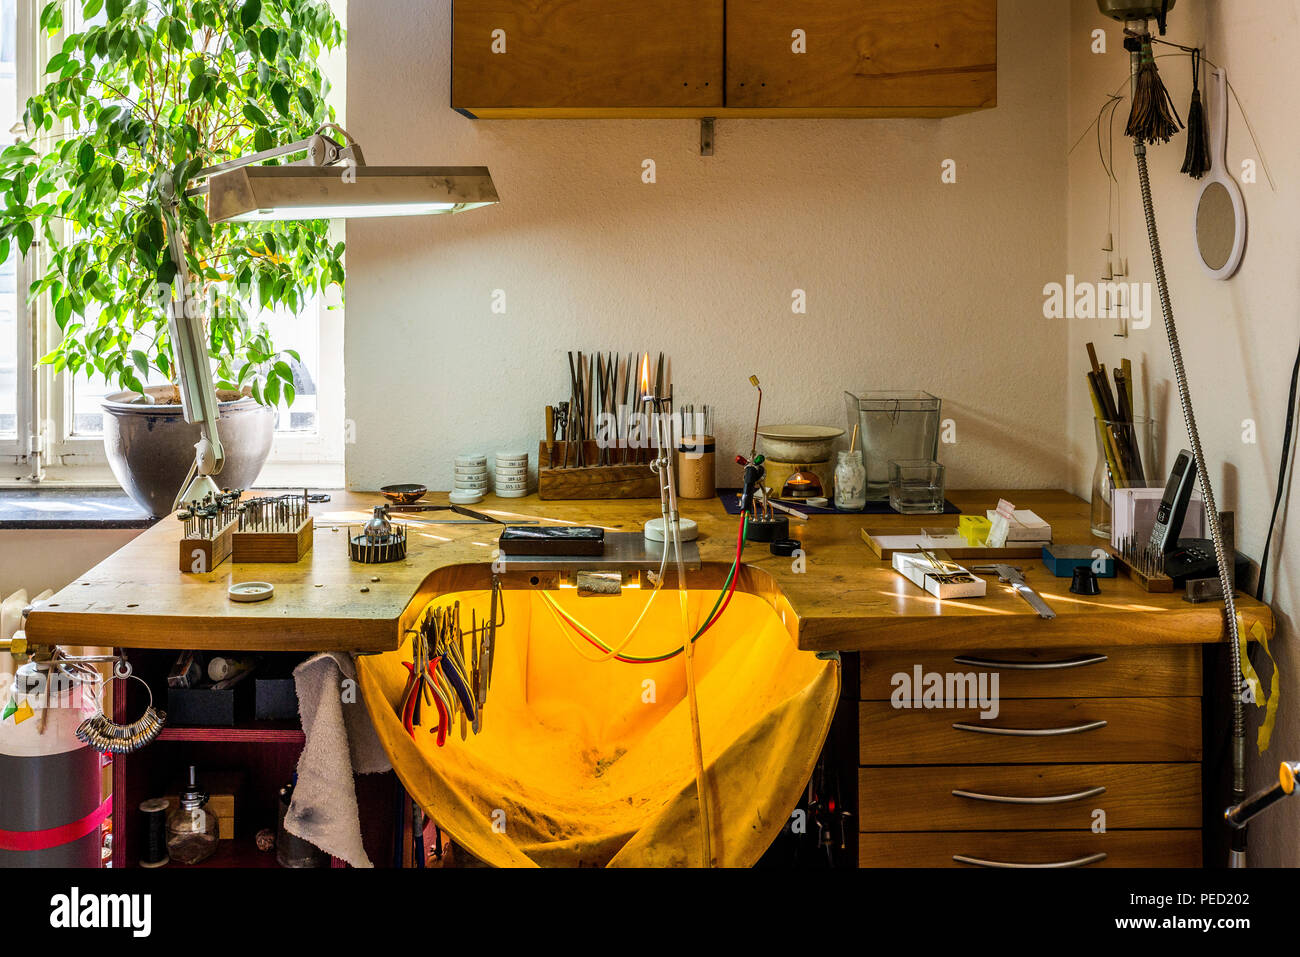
left=208, top=166, right=498, bottom=222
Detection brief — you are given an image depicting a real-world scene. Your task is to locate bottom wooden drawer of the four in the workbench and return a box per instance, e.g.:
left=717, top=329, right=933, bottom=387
left=858, top=831, right=1201, bottom=867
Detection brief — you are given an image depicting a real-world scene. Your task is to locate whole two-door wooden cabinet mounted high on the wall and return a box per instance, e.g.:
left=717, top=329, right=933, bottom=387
left=451, top=0, right=997, bottom=118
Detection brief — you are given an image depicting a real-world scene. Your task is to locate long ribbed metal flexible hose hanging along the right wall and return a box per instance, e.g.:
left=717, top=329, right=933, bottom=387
left=1134, top=140, right=1245, bottom=816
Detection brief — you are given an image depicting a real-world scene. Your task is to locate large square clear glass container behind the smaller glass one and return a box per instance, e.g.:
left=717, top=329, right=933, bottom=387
left=844, top=391, right=941, bottom=502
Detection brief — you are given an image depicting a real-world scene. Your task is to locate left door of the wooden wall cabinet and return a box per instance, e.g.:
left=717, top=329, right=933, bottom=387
left=451, top=0, right=724, bottom=117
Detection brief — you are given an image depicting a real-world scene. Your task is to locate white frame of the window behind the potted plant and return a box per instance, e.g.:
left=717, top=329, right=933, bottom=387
left=0, top=0, right=347, bottom=488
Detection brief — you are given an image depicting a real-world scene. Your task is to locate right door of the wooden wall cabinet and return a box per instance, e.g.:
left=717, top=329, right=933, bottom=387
left=727, top=0, right=997, bottom=116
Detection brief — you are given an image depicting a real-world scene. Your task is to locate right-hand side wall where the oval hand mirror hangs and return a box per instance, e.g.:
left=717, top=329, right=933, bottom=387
left=1069, top=0, right=1300, bottom=867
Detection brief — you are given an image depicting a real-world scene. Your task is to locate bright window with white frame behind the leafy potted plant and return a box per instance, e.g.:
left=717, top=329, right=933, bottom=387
left=0, top=0, right=346, bottom=488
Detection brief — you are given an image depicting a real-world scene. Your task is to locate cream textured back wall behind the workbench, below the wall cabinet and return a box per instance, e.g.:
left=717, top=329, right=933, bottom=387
left=346, top=0, right=1069, bottom=489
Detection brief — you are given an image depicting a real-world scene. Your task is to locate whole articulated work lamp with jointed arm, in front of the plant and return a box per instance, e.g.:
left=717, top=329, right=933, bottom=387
left=161, top=124, right=498, bottom=506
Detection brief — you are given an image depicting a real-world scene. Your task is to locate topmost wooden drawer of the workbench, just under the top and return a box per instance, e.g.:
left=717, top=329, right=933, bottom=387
left=859, top=645, right=1201, bottom=701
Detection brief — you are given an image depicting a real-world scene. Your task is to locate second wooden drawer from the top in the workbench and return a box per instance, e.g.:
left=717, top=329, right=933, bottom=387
left=858, top=698, right=1201, bottom=765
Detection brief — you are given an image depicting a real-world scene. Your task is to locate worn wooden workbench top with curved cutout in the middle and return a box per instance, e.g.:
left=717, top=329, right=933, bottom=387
left=27, top=492, right=1274, bottom=651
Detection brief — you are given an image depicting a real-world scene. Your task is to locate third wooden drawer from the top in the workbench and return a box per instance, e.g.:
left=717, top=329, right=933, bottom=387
left=858, top=765, right=1201, bottom=831
